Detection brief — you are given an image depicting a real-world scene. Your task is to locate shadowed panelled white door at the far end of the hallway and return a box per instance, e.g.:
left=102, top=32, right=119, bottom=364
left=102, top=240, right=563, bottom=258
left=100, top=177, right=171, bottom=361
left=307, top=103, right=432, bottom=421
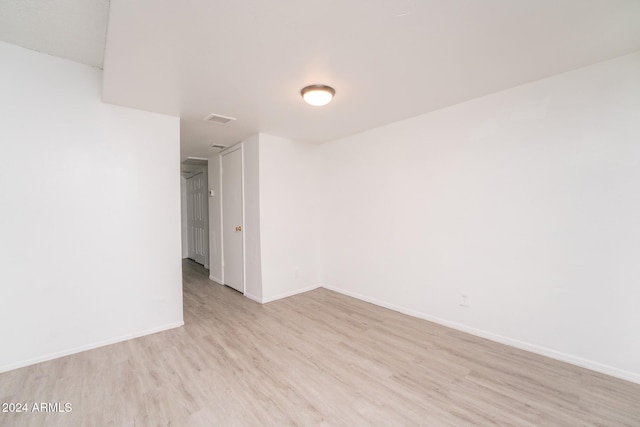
left=187, top=171, right=209, bottom=266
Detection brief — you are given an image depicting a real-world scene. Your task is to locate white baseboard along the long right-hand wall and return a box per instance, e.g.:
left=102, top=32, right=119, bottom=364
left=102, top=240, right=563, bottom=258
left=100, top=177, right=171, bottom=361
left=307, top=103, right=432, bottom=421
left=322, top=284, right=640, bottom=384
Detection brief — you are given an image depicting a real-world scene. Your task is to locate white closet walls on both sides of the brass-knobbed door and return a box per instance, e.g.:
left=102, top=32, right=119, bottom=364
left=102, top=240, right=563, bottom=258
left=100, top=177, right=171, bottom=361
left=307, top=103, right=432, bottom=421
left=209, top=134, right=320, bottom=303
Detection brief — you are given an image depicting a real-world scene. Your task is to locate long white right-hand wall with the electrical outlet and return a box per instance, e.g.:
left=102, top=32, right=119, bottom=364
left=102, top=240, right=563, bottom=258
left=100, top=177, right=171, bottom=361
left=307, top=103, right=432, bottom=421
left=319, top=54, right=640, bottom=382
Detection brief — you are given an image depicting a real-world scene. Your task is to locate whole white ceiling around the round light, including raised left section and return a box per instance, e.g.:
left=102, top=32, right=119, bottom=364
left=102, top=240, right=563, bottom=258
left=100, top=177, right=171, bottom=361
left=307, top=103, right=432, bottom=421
left=0, top=0, right=640, bottom=159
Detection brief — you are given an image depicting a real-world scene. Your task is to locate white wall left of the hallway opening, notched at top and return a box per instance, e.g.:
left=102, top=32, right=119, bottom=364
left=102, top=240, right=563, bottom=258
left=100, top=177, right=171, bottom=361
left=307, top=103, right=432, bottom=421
left=0, top=43, right=182, bottom=371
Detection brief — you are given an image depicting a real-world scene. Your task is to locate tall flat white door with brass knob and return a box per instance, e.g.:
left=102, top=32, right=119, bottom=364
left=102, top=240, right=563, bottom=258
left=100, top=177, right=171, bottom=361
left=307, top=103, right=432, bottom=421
left=221, top=146, right=244, bottom=293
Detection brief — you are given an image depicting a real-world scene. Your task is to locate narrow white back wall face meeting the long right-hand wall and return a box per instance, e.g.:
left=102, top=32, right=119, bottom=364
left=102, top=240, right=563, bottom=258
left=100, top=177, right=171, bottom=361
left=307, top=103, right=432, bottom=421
left=259, top=134, right=320, bottom=302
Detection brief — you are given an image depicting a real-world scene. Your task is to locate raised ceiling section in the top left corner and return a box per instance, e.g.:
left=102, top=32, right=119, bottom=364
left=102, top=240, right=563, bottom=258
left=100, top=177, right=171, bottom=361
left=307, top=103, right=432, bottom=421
left=0, top=0, right=109, bottom=68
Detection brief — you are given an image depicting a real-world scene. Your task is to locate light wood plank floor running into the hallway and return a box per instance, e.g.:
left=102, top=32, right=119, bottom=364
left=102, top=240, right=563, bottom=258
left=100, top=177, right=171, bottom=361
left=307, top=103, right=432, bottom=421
left=0, top=261, right=640, bottom=426
